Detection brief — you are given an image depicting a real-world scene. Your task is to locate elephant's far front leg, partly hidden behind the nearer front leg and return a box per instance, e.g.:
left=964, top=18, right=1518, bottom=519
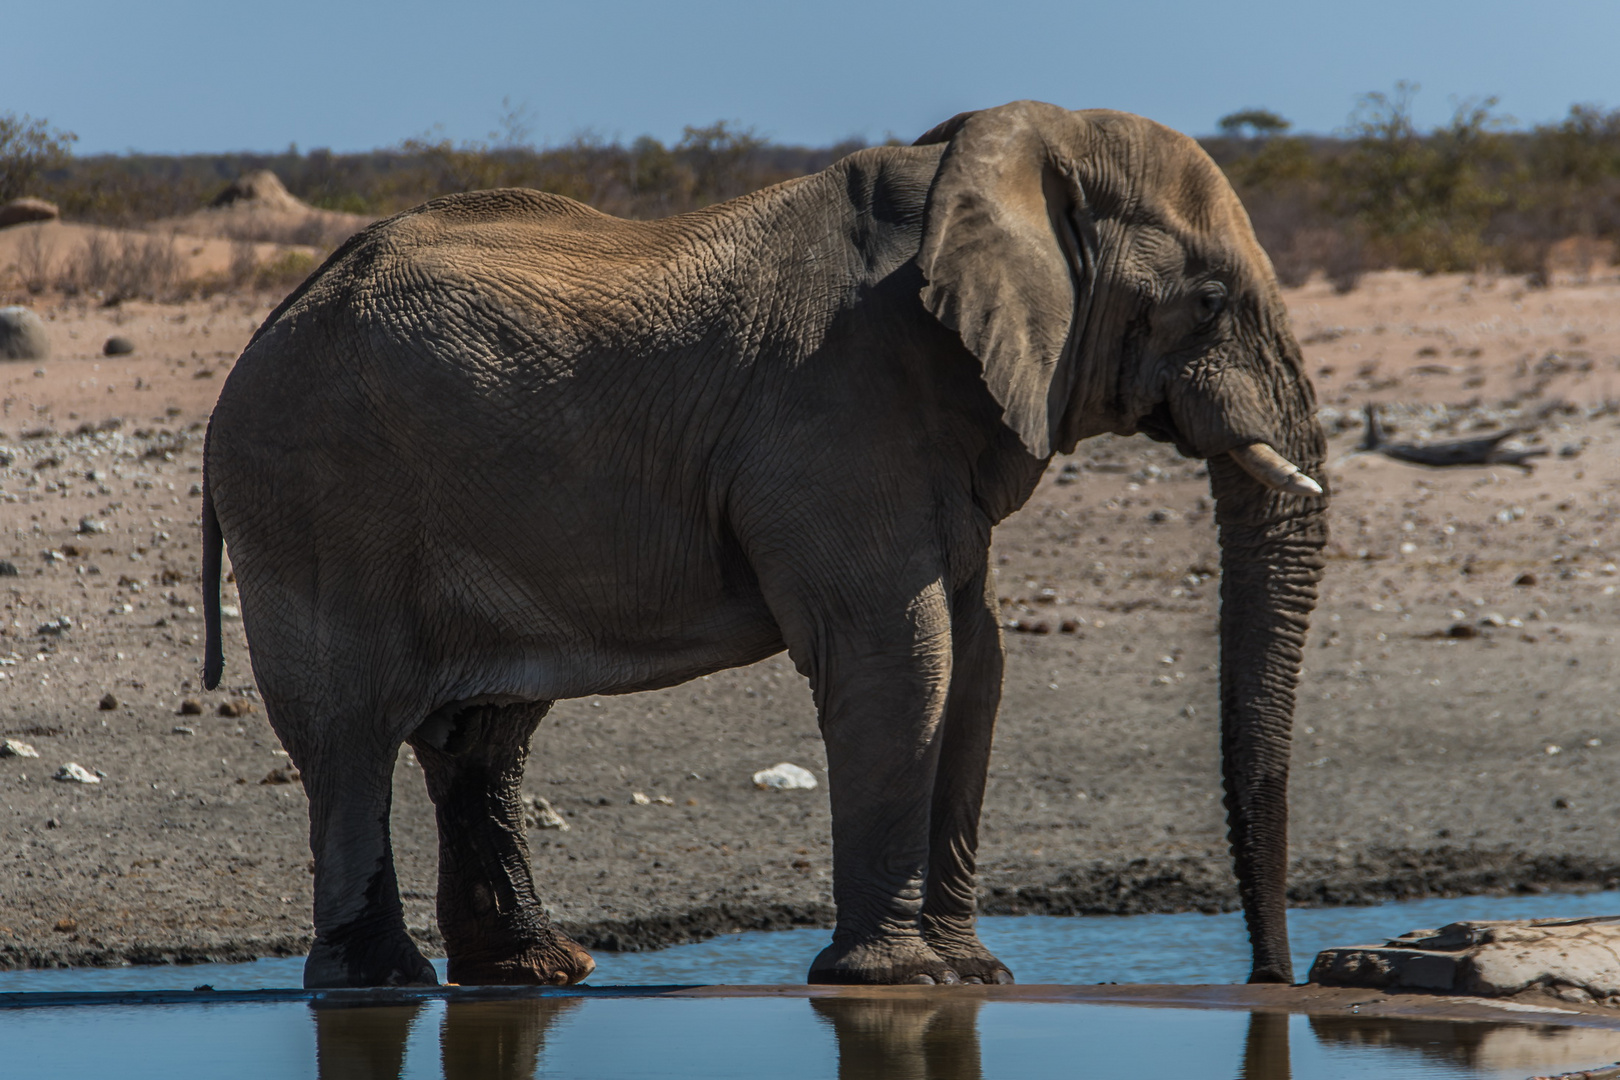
left=922, top=573, right=1013, bottom=983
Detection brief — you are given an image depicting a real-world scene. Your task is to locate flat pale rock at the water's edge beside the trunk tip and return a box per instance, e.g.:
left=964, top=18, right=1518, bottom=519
left=1311, top=915, right=1620, bottom=1007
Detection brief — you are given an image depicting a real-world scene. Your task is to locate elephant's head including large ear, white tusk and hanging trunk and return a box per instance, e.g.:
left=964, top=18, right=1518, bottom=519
left=919, top=102, right=1327, bottom=981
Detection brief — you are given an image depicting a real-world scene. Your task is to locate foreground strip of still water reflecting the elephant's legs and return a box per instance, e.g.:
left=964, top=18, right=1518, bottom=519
left=0, top=989, right=1620, bottom=1080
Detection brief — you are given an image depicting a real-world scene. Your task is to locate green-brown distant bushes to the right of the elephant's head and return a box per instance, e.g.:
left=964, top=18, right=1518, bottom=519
left=1205, top=83, right=1620, bottom=288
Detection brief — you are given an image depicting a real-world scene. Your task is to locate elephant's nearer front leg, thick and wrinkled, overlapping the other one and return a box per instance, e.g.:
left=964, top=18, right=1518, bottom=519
left=810, top=591, right=961, bottom=984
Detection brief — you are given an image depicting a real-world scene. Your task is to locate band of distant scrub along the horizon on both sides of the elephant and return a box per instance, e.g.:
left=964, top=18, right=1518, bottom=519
left=19, top=91, right=1620, bottom=288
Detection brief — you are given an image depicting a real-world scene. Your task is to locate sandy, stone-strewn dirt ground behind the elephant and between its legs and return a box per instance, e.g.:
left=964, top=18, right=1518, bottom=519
left=0, top=274, right=1620, bottom=967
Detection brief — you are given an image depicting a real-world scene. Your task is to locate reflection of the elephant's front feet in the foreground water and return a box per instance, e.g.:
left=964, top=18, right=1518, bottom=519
left=810, top=994, right=983, bottom=1080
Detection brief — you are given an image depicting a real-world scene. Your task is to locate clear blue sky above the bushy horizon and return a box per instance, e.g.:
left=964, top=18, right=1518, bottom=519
left=0, top=0, right=1620, bottom=154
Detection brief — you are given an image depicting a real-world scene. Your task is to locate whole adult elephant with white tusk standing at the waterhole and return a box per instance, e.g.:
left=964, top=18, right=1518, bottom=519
left=203, top=102, right=1325, bottom=986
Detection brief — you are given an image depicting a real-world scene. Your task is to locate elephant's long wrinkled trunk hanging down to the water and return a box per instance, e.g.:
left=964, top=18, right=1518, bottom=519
left=1209, top=356, right=1327, bottom=983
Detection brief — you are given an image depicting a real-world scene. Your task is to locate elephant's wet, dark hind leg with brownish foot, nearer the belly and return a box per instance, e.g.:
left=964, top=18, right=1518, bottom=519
left=410, top=701, right=596, bottom=986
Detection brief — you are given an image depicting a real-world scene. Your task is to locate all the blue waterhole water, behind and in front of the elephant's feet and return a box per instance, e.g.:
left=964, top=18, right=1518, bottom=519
left=0, top=892, right=1620, bottom=1080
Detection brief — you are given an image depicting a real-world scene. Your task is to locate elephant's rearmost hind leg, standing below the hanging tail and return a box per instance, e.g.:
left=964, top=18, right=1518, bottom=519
left=301, top=735, right=439, bottom=988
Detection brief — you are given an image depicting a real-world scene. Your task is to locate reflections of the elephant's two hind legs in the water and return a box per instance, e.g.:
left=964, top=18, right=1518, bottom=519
left=309, top=997, right=580, bottom=1080
